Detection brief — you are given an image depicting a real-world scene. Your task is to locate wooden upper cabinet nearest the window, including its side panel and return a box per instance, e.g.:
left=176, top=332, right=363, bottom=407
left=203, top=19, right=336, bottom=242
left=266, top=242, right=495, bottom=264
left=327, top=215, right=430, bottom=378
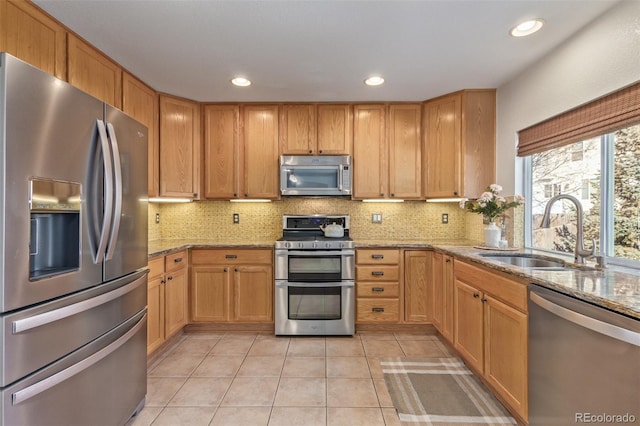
left=424, top=89, right=496, bottom=198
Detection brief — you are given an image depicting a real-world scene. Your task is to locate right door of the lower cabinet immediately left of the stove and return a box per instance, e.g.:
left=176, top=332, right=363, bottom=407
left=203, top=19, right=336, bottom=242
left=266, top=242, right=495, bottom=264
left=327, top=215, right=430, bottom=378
left=233, top=265, right=273, bottom=322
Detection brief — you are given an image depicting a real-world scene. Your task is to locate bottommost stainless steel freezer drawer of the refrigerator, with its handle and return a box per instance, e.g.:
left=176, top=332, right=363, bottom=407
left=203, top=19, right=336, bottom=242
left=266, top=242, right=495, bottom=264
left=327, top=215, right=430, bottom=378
left=0, top=309, right=147, bottom=426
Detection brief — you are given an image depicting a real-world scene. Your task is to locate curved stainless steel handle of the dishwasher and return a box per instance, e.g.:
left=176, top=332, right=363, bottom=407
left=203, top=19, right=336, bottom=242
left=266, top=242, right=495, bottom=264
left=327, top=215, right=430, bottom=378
left=529, top=291, right=640, bottom=346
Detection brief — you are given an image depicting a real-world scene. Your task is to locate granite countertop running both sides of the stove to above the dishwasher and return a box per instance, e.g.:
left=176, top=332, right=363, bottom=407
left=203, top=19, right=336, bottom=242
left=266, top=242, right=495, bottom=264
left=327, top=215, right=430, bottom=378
left=148, top=239, right=640, bottom=320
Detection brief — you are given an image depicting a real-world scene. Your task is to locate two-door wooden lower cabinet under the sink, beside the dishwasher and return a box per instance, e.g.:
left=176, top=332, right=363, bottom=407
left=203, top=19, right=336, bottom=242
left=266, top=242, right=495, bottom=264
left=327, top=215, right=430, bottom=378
left=454, top=261, right=528, bottom=421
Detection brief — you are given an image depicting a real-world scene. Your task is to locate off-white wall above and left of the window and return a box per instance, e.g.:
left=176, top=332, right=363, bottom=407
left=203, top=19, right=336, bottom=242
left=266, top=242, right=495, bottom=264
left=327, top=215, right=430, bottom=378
left=496, top=0, right=640, bottom=194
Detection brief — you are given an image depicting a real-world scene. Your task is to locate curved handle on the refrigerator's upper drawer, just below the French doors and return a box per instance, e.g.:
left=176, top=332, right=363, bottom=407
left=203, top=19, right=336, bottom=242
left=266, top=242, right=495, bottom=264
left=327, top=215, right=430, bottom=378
left=12, top=274, right=146, bottom=334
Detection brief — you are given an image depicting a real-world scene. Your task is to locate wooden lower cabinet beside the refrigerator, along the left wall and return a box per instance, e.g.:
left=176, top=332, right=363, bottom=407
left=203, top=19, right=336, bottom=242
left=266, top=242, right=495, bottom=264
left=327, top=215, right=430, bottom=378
left=147, top=251, right=188, bottom=353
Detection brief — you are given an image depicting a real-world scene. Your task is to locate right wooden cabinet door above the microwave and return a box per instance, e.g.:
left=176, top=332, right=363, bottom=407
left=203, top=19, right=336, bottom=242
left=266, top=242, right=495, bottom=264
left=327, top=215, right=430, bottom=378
left=317, top=104, right=353, bottom=155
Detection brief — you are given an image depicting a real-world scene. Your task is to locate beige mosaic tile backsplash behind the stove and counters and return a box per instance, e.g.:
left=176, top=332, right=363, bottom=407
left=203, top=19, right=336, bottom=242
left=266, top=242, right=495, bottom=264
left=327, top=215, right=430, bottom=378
left=149, top=198, right=482, bottom=241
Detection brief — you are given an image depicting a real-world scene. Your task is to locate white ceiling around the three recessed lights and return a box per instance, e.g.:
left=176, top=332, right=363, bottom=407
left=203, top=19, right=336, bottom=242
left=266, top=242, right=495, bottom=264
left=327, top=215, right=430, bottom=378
left=34, top=0, right=618, bottom=102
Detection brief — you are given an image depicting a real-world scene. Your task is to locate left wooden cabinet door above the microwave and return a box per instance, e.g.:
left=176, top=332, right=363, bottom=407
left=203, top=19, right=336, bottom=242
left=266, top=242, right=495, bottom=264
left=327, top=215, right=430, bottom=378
left=280, top=104, right=317, bottom=155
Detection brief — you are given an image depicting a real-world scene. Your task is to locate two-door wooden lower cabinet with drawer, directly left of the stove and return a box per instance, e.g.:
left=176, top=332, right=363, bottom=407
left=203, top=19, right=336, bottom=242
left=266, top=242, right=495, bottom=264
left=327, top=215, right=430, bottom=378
left=191, top=249, right=273, bottom=323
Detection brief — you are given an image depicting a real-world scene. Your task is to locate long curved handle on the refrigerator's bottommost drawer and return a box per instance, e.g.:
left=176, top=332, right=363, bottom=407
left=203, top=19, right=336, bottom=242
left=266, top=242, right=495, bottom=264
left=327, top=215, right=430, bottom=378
left=11, top=313, right=147, bottom=405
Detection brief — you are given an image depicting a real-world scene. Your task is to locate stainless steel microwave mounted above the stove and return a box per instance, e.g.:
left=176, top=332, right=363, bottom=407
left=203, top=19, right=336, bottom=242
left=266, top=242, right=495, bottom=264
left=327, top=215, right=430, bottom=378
left=280, top=155, right=351, bottom=196
